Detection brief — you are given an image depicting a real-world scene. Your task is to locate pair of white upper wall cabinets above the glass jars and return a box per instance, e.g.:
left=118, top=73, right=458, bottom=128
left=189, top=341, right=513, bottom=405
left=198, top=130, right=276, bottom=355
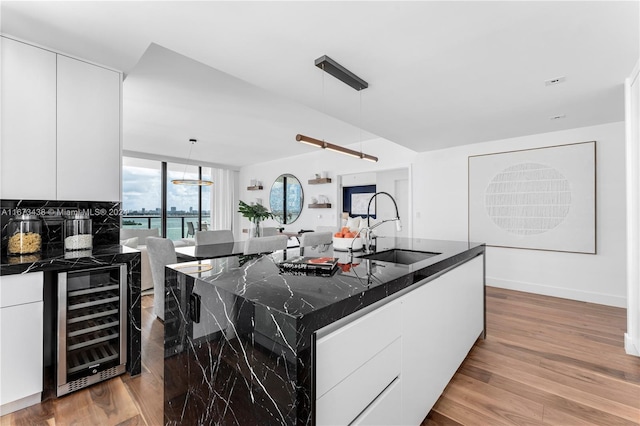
left=0, top=37, right=121, bottom=201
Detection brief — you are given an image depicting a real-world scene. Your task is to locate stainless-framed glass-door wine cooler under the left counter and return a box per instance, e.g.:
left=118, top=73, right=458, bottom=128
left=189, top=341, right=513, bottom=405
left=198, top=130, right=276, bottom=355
left=56, top=264, right=127, bottom=396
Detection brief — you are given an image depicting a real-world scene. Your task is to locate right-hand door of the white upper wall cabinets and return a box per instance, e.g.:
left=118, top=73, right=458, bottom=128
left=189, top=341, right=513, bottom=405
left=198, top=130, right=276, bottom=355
left=57, top=55, right=120, bottom=201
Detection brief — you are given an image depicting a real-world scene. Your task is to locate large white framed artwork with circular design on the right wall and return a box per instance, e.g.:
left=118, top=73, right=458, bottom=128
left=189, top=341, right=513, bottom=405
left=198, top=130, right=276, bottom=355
left=469, top=142, right=596, bottom=253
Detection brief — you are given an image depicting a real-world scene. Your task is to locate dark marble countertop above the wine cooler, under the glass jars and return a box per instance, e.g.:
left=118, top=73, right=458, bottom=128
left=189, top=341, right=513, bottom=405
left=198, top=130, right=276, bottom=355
left=0, top=244, right=140, bottom=275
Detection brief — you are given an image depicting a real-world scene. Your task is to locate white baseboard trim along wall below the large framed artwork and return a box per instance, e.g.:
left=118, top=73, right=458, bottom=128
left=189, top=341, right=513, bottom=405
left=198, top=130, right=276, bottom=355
left=486, top=277, right=627, bottom=308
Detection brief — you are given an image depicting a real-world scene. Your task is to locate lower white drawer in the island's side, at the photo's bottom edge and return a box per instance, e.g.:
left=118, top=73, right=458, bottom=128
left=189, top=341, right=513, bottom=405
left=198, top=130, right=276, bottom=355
left=316, top=338, right=402, bottom=425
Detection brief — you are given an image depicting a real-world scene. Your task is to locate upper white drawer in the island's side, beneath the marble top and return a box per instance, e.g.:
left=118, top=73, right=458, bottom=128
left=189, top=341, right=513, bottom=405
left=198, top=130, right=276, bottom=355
left=316, top=301, right=402, bottom=399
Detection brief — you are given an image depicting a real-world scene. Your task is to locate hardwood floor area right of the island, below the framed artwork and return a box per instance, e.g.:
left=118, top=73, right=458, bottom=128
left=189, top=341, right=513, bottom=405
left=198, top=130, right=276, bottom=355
left=422, top=288, right=640, bottom=426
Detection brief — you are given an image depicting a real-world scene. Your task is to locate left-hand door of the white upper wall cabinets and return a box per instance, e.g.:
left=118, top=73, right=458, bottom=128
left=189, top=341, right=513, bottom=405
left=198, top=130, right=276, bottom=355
left=0, top=37, right=56, bottom=200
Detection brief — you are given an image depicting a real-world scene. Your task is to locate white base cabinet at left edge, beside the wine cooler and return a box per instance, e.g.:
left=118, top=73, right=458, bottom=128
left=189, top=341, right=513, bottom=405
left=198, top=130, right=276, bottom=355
left=0, top=272, right=44, bottom=415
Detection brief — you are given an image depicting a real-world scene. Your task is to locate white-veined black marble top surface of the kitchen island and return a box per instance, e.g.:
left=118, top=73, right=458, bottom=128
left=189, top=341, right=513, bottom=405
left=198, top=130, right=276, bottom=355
left=168, top=238, right=484, bottom=336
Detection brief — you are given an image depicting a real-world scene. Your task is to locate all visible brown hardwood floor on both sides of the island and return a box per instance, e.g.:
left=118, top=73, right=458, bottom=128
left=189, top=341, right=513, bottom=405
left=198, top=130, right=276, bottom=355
left=0, top=287, right=640, bottom=426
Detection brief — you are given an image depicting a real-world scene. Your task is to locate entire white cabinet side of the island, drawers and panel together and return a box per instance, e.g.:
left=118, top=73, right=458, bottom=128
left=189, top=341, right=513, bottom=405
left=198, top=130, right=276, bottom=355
left=315, top=256, right=484, bottom=426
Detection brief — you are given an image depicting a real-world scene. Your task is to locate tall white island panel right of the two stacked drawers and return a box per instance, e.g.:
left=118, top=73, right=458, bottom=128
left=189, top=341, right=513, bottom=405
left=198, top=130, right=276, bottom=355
left=400, top=256, right=484, bottom=425
